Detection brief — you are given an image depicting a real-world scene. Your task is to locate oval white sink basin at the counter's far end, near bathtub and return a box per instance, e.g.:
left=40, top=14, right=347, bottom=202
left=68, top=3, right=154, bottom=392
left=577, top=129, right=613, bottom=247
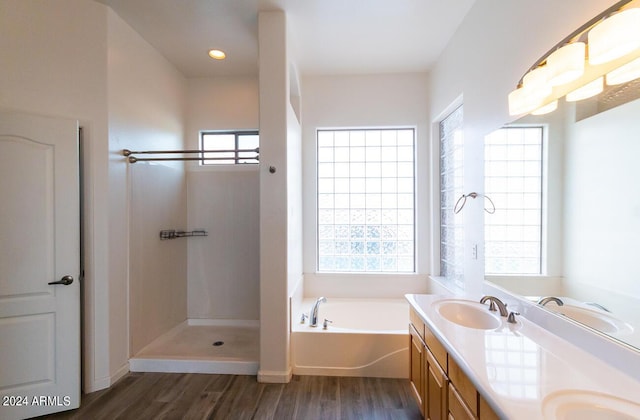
left=434, top=299, right=501, bottom=330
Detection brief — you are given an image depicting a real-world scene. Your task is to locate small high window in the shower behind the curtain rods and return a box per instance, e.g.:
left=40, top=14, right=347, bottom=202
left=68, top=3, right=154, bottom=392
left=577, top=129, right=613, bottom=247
left=199, top=131, right=260, bottom=165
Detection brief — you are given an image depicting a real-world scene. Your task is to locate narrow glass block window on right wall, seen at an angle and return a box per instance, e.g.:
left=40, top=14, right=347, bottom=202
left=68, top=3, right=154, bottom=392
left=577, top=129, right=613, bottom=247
left=440, top=106, right=464, bottom=288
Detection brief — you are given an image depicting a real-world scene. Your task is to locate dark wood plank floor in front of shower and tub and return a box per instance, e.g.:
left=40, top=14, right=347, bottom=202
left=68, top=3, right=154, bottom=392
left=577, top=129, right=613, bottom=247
left=38, top=373, right=421, bottom=420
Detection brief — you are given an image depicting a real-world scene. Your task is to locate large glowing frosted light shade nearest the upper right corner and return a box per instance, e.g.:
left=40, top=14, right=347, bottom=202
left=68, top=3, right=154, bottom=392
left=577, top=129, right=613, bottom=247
left=588, top=8, right=640, bottom=65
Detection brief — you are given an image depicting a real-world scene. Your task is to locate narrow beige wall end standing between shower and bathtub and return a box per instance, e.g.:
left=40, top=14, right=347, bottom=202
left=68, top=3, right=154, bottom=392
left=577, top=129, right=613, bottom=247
left=258, top=11, right=301, bottom=382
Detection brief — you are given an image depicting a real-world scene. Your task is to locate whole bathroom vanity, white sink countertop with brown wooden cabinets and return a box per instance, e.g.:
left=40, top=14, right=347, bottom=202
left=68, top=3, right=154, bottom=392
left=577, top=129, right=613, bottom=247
left=406, top=295, right=640, bottom=419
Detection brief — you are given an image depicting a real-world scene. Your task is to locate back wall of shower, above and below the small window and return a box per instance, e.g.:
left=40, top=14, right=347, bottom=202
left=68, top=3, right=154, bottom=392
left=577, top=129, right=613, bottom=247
left=186, top=76, right=260, bottom=320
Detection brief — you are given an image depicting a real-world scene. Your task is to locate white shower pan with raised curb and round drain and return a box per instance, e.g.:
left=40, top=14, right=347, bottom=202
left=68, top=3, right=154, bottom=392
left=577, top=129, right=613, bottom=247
left=129, top=319, right=259, bottom=375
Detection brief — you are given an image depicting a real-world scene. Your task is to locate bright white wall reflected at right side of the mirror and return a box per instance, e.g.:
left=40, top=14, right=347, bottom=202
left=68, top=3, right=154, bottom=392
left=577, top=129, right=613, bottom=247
left=564, top=100, right=640, bottom=325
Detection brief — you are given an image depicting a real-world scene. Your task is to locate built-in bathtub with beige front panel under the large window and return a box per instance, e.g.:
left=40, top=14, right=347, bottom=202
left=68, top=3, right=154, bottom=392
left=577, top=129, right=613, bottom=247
left=291, top=298, right=409, bottom=378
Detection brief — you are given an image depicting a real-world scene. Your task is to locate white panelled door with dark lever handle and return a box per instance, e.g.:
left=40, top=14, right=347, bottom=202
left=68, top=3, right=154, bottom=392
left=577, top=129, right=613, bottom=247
left=0, top=112, right=80, bottom=420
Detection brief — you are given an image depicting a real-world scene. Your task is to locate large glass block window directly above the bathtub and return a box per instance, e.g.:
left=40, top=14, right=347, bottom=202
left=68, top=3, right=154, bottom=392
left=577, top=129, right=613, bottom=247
left=317, top=128, right=415, bottom=272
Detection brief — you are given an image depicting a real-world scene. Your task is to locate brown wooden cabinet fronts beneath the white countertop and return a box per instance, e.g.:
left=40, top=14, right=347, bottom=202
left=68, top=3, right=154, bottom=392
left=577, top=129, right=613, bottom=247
left=409, top=308, right=498, bottom=420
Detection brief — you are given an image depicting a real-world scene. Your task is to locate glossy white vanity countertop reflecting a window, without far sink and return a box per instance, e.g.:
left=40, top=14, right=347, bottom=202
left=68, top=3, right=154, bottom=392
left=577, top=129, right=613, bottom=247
left=406, top=294, right=640, bottom=420
